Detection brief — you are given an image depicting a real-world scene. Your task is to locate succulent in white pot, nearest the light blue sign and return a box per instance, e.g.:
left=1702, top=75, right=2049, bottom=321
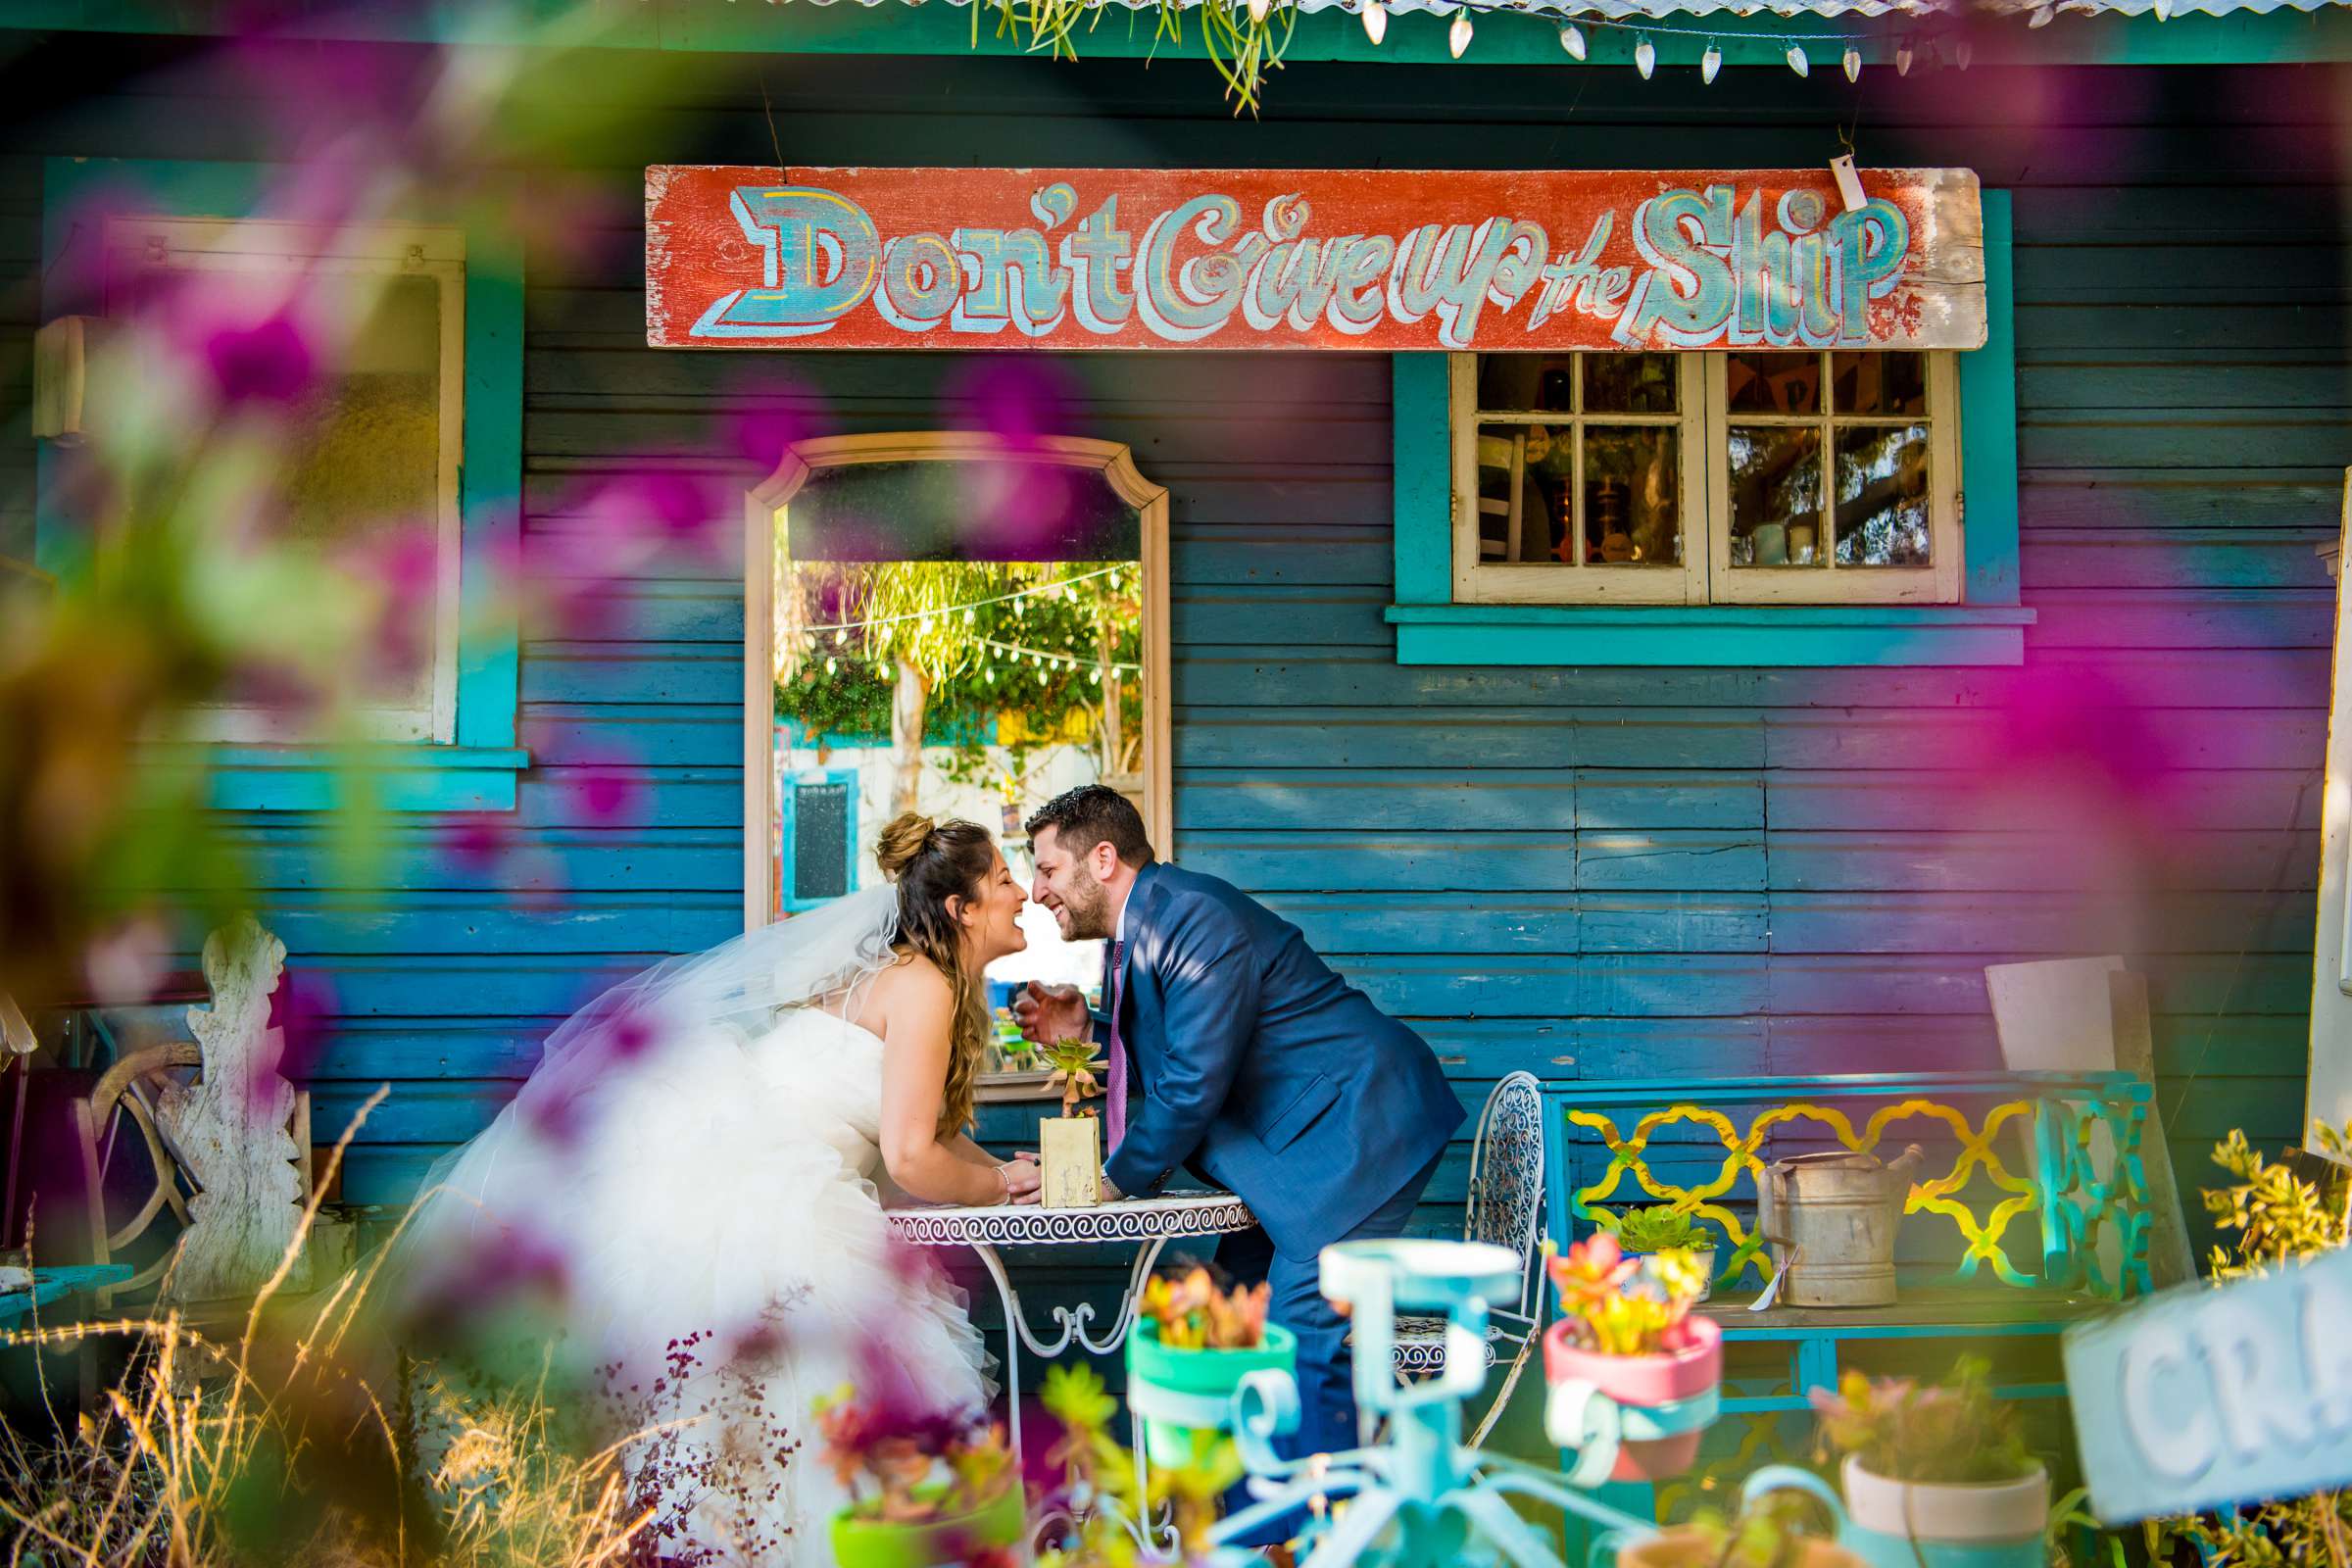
left=1813, top=1356, right=2051, bottom=1568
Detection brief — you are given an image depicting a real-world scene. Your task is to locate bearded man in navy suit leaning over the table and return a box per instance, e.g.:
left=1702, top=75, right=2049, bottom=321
left=1013, top=785, right=1463, bottom=1452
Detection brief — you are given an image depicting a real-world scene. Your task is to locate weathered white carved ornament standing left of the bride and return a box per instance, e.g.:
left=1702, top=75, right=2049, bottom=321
left=155, top=914, right=304, bottom=1300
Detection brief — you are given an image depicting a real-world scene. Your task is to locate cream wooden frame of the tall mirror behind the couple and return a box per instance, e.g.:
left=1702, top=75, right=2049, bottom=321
left=743, top=430, right=1176, bottom=931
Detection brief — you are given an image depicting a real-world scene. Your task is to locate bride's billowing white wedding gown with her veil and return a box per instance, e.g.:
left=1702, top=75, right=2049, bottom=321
left=402, top=893, right=990, bottom=1568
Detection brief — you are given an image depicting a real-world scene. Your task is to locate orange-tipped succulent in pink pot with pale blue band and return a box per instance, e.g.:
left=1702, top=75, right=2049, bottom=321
left=1543, top=1232, right=1724, bottom=1486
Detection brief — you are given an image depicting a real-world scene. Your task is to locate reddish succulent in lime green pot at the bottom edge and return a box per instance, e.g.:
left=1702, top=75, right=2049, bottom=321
left=816, top=1387, right=1028, bottom=1568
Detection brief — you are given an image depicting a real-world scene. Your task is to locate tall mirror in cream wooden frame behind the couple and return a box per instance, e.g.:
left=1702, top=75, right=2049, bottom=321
left=743, top=430, right=1169, bottom=1084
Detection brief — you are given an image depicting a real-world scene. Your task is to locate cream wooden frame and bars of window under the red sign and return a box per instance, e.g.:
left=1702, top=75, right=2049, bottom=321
left=1446, top=350, right=1966, bottom=607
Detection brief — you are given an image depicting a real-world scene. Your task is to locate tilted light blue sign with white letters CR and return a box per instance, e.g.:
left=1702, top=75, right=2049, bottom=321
left=2065, top=1249, right=2352, bottom=1523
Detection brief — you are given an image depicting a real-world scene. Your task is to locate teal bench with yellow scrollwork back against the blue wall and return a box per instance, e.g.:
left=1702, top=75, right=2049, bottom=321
left=1543, top=1072, right=2154, bottom=1504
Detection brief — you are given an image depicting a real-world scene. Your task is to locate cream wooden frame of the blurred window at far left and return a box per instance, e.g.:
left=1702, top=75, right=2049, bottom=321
left=106, top=214, right=466, bottom=745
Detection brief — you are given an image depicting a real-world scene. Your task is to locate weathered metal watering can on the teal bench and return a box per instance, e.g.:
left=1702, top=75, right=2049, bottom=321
left=1757, top=1143, right=1927, bottom=1309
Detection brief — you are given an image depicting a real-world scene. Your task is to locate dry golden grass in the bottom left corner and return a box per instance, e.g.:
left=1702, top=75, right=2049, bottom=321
left=0, top=1091, right=657, bottom=1568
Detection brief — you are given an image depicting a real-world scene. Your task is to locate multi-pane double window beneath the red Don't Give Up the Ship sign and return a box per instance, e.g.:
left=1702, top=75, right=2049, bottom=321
left=1448, top=350, right=1962, bottom=604
